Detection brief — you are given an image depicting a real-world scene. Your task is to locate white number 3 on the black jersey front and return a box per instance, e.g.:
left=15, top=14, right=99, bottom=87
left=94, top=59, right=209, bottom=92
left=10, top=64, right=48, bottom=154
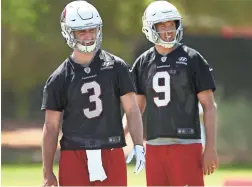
left=81, top=81, right=103, bottom=119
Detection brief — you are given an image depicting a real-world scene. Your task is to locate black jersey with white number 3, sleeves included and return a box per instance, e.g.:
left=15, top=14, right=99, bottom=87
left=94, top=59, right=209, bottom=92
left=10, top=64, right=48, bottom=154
left=41, top=50, right=135, bottom=149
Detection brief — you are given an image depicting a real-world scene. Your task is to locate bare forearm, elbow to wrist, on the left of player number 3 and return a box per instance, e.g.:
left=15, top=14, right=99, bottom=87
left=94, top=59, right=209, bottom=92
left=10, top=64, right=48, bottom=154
left=42, top=127, right=59, bottom=174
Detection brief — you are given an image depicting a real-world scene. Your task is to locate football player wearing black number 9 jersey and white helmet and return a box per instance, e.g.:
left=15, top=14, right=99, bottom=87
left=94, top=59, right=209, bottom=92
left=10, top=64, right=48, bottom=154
left=128, top=1, right=218, bottom=186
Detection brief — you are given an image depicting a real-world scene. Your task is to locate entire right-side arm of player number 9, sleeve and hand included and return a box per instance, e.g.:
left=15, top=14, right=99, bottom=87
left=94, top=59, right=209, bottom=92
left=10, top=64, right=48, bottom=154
left=195, top=51, right=218, bottom=175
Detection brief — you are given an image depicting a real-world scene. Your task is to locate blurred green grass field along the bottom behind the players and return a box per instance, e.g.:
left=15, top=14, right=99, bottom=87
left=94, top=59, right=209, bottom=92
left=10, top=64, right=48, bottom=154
left=2, top=165, right=252, bottom=186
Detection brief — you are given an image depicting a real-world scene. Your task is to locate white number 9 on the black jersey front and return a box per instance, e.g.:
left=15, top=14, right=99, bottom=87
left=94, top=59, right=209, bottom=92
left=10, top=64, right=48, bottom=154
left=152, top=71, right=171, bottom=107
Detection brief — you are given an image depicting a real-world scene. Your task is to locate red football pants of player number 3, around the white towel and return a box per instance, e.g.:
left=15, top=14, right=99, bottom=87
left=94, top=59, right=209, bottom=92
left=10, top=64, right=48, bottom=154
left=59, top=148, right=127, bottom=186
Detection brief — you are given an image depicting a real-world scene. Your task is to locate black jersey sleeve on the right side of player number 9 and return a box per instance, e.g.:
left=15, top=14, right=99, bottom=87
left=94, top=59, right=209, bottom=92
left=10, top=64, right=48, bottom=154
left=195, top=53, right=216, bottom=94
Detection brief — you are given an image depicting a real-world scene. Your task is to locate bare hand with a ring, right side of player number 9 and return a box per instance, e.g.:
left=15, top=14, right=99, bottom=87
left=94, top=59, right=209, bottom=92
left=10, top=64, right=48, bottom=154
left=203, top=148, right=219, bottom=175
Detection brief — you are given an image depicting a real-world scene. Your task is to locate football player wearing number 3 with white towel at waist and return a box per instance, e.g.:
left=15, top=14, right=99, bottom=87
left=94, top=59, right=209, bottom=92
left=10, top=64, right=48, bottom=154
left=41, top=1, right=145, bottom=186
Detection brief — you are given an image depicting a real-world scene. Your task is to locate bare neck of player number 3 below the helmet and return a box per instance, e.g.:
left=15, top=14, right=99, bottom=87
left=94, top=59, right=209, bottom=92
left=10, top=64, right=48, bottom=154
left=71, top=49, right=95, bottom=64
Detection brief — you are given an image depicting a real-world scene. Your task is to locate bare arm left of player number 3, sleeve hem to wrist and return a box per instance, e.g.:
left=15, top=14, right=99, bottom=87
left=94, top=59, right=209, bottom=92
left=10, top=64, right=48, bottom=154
left=42, top=110, right=61, bottom=176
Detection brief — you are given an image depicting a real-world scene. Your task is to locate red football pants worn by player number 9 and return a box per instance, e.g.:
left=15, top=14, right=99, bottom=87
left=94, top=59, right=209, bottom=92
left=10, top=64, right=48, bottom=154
left=146, top=144, right=204, bottom=186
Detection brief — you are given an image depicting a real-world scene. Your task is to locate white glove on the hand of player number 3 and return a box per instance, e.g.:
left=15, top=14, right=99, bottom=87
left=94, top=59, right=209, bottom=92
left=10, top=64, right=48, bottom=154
left=126, top=145, right=145, bottom=174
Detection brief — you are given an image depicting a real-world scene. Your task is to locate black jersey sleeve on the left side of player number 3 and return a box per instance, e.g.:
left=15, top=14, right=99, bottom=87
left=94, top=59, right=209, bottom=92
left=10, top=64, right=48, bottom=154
left=41, top=72, right=64, bottom=112
